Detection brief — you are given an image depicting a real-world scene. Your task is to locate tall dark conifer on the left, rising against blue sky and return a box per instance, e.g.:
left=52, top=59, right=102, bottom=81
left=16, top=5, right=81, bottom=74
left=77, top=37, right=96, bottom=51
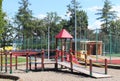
left=15, top=0, right=33, bottom=38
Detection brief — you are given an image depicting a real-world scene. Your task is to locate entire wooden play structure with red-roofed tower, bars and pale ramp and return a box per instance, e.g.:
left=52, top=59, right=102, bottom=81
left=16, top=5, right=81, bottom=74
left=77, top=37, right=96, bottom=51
left=0, top=29, right=111, bottom=78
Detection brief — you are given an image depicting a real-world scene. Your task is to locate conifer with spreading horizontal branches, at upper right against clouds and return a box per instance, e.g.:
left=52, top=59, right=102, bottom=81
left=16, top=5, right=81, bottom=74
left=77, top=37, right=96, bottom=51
left=96, top=0, right=116, bottom=33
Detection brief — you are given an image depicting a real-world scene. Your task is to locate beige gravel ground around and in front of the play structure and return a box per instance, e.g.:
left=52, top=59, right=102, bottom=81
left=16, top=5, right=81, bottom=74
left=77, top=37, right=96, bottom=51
left=0, top=58, right=120, bottom=81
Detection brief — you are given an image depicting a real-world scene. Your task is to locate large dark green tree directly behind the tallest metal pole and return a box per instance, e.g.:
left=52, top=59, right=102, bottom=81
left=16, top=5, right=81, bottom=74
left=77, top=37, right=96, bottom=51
left=67, top=0, right=88, bottom=37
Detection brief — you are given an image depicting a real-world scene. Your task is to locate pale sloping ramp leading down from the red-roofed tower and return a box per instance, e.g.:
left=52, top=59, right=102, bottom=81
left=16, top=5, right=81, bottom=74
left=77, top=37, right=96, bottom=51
left=58, top=62, right=111, bottom=78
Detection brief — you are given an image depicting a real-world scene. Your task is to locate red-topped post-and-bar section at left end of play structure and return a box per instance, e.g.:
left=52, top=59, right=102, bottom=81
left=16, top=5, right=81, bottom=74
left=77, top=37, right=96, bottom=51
left=0, top=51, right=44, bottom=73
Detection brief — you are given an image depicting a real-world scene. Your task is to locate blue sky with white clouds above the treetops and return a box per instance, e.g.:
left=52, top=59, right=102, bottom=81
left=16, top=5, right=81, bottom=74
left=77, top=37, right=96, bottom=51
left=3, top=0, right=120, bottom=29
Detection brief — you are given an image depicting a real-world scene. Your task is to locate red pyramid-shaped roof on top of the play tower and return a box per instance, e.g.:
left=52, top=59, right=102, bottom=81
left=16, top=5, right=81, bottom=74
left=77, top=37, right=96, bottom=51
left=55, top=29, right=73, bottom=38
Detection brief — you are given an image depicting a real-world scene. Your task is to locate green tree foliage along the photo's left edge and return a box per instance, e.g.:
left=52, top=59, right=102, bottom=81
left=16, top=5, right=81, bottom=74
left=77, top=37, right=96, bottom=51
left=0, top=0, right=13, bottom=50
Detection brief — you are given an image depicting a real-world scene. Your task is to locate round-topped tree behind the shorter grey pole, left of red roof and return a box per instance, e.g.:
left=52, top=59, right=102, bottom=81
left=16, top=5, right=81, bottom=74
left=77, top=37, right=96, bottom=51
left=44, top=12, right=61, bottom=49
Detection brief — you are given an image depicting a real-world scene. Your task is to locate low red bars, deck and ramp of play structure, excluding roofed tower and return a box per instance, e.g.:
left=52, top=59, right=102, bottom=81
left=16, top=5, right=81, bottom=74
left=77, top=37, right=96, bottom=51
left=1, top=50, right=111, bottom=78
